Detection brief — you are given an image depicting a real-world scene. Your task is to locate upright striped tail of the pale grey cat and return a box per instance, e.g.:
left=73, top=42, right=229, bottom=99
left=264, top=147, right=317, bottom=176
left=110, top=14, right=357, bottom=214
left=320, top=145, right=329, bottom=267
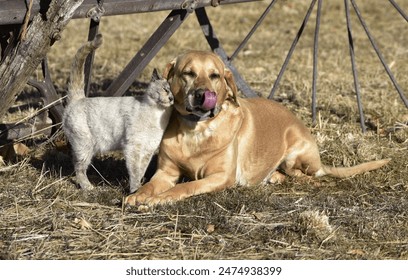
left=67, top=34, right=102, bottom=103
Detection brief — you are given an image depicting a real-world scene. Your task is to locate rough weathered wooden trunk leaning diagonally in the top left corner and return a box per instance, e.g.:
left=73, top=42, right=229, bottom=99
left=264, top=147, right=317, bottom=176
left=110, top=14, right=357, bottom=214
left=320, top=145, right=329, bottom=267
left=0, top=0, right=84, bottom=118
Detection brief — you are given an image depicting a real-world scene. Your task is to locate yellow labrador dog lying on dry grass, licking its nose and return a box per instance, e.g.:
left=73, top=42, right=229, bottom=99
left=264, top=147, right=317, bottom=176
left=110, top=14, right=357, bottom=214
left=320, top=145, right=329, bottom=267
left=125, top=51, right=389, bottom=205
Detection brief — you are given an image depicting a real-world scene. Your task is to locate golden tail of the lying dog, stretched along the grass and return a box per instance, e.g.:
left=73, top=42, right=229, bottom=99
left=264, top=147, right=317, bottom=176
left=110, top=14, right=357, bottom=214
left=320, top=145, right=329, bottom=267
left=316, top=159, right=391, bottom=178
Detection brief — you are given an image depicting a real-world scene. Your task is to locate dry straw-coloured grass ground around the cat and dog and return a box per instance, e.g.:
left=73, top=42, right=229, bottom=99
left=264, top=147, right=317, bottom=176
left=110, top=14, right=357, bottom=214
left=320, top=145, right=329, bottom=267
left=0, top=0, right=408, bottom=260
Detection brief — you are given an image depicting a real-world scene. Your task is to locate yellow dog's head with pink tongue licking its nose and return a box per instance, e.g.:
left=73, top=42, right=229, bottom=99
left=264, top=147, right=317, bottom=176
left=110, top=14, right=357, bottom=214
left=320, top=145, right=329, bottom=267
left=163, top=51, right=237, bottom=120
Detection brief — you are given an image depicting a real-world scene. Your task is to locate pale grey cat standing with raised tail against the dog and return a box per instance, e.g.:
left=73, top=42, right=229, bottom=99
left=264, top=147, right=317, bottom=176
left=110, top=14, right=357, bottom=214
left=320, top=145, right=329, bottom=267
left=62, top=35, right=174, bottom=193
